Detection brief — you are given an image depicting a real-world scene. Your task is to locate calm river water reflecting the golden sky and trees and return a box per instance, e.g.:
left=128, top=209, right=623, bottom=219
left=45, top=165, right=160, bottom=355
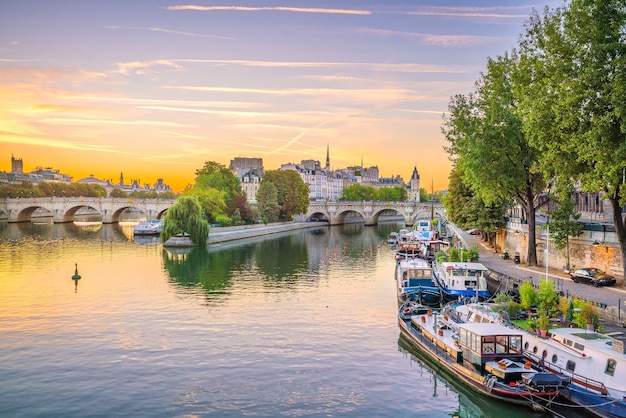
left=0, top=222, right=572, bottom=418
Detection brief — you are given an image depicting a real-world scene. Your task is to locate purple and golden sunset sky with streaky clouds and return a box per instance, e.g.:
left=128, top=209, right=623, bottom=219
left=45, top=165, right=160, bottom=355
left=0, top=0, right=561, bottom=192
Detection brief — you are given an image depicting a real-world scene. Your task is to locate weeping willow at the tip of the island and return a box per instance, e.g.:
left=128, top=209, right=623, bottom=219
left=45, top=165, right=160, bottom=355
left=161, top=196, right=209, bottom=247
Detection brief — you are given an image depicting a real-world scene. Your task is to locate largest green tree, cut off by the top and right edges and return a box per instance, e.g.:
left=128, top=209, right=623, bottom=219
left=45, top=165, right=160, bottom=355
left=520, top=0, right=626, bottom=280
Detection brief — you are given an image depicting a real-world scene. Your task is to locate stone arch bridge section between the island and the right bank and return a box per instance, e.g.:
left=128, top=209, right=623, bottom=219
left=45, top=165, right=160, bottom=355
left=306, top=201, right=445, bottom=225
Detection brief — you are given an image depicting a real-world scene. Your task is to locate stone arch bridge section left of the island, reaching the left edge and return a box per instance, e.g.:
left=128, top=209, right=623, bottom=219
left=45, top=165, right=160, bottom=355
left=0, top=197, right=175, bottom=224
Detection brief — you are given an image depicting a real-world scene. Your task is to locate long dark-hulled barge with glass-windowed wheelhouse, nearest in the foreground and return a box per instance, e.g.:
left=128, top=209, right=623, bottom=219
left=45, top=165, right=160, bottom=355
left=398, top=306, right=569, bottom=409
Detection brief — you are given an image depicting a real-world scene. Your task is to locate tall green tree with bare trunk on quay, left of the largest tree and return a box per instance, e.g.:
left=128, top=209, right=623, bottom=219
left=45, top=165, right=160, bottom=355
left=442, top=52, right=546, bottom=266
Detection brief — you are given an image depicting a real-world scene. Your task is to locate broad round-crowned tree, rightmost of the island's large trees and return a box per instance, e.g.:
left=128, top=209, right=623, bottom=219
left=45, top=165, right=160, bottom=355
left=257, top=170, right=309, bottom=220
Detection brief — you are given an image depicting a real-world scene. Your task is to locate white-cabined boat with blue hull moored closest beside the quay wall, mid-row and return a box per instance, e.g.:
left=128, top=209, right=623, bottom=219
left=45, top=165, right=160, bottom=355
left=433, top=261, right=491, bottom=302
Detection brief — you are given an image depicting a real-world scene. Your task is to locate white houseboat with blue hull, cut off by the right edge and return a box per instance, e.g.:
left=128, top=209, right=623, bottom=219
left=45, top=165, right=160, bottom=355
left=447, top=303, right=626, bottom=418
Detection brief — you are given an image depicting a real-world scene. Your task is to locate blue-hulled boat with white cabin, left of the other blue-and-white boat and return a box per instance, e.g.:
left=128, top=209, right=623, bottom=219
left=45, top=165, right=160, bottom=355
left=396, top=258, right=442, bottom=306
